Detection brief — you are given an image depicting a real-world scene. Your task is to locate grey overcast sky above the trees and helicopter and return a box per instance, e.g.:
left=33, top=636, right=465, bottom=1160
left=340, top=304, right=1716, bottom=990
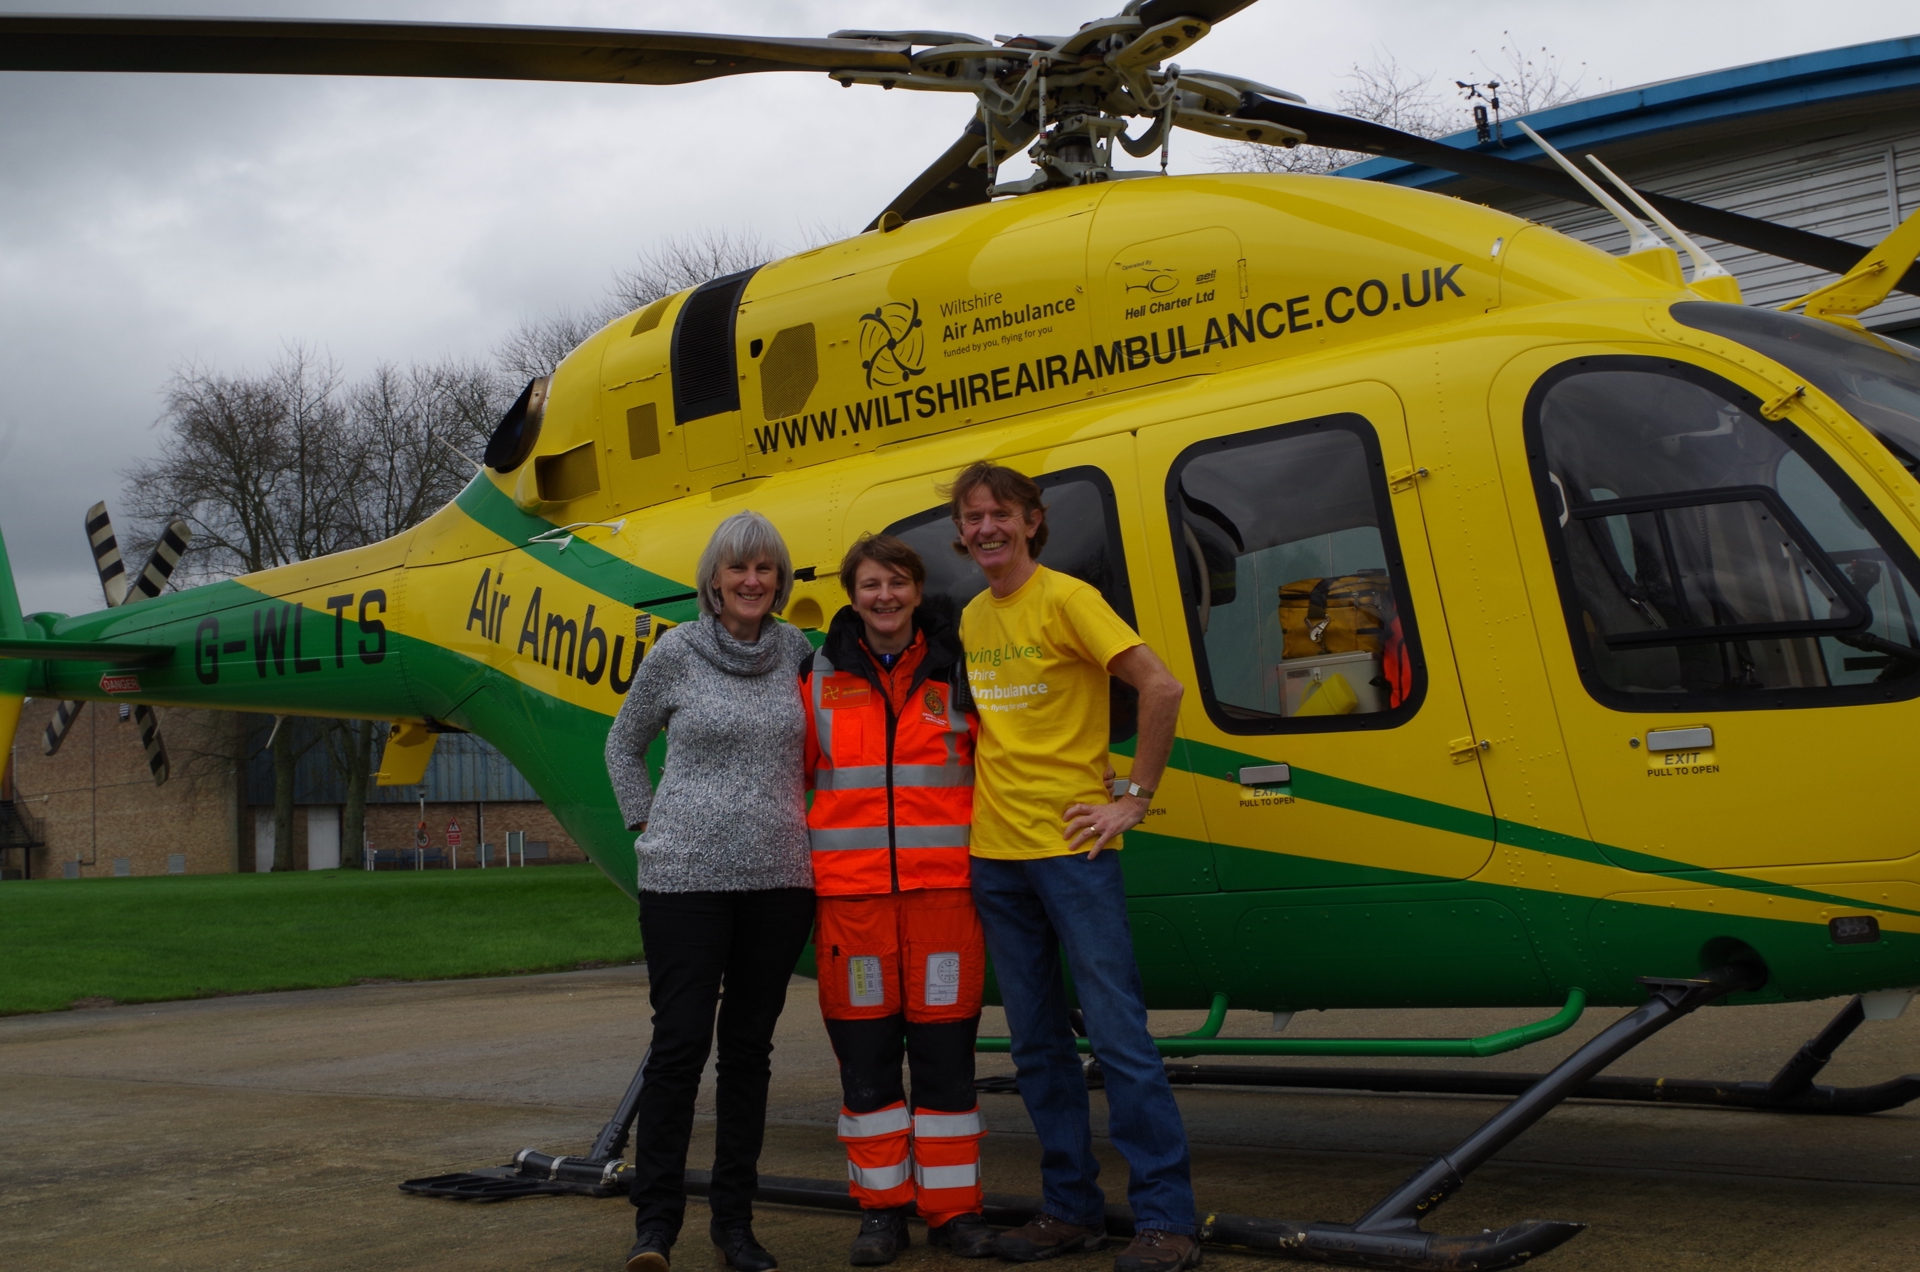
left=0, top=0, right=1920, bottom=613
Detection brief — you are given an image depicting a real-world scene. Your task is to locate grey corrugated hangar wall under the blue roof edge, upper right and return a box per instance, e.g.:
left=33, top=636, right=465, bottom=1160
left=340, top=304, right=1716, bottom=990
left=1476, top=111, right=1920, bottom=329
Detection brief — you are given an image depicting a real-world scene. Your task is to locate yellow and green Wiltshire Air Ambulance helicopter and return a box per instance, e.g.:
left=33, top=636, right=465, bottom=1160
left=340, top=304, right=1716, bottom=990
left=0, top=0, right=1920, bottom=1268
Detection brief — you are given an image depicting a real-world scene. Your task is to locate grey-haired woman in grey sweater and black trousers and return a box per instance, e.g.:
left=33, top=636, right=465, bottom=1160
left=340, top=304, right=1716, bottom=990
left=607, top=513, right=814, bottom=1272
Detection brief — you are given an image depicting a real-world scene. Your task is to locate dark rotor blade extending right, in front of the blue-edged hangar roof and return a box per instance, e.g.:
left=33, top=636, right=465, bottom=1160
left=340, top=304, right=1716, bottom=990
left=1235, top=92, right=1920, bottom=294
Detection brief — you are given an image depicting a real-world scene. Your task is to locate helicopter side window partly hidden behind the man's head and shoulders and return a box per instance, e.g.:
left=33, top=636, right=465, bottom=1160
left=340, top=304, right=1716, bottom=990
left=883, top=467, right=1139, bottom=742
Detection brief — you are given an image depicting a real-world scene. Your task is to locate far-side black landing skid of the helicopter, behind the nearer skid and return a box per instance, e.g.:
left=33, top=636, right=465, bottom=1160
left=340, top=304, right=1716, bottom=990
left=1052, top=997, right=1920, bottom=1116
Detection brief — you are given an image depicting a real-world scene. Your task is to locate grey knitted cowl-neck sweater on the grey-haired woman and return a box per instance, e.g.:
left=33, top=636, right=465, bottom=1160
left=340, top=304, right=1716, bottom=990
left=607, top=619, right=814, bottom=892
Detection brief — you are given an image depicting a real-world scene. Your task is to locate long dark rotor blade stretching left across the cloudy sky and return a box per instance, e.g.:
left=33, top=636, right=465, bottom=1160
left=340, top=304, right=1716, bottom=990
left=0, top=15, right=912, bottom=85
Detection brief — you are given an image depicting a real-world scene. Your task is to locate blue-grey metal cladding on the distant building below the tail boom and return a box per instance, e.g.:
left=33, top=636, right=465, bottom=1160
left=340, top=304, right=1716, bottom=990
left=246, top=717, right=540, bottom=803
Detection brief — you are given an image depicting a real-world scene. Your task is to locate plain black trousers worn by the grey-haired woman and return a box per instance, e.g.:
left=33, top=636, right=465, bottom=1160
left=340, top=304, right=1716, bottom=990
left=630, top=888, right=814, bottom=1241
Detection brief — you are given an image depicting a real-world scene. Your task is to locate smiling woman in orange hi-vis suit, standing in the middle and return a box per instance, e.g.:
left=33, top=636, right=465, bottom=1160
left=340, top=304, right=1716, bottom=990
left=801, top=536, right=995, bottom=1266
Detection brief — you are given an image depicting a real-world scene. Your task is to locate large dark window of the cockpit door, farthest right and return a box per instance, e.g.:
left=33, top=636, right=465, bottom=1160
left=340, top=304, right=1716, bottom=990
left=1526, top=357, right=1920, bottom=709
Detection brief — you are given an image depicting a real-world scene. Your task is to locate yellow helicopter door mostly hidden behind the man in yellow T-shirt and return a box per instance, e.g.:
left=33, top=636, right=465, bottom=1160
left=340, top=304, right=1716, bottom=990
left=847, top=443, right=1215, bottom=897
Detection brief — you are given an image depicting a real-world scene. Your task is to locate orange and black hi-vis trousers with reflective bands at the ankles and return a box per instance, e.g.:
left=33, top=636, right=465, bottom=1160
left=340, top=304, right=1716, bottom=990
left=814, top=888, right=985, bottom=1226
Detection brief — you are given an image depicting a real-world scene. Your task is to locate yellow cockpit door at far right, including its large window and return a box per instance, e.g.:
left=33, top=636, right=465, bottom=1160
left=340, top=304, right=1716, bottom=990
left=1494, top=355, right=1920, bottom=870
